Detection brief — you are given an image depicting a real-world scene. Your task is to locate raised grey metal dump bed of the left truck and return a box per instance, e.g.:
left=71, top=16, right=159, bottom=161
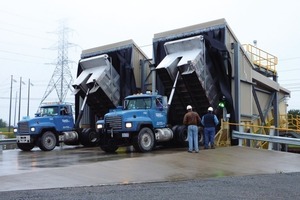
left=73, top=54, right=120, bottom=113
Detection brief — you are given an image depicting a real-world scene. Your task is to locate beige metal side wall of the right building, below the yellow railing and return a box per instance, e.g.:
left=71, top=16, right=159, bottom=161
left=215, top=19, right=290, bottom=128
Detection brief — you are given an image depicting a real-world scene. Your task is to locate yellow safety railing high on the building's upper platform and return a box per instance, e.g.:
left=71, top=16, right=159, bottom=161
left=243, top=44, right=278, bottom=74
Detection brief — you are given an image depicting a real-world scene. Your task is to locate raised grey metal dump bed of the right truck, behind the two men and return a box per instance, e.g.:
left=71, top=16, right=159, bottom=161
left=156, top=35, right=218, bottom=124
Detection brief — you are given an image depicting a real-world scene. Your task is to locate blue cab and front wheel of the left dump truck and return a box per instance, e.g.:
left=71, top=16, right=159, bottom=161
left=14, top=103, right=74, bottom=151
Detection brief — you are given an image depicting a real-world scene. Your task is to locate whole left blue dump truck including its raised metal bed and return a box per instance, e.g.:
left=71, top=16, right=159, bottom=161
left=14, top=55, right=118, bottom=151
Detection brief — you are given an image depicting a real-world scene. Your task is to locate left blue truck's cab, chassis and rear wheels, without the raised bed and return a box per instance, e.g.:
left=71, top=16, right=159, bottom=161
left=14, top=102, right=98, bottom=151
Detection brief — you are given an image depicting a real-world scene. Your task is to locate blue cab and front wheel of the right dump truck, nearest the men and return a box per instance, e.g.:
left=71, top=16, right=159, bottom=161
left=97, top=93, right=172, bottom=152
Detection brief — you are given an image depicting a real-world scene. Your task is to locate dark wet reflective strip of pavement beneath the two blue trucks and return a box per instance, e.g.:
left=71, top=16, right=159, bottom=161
left=0, top=147, right=183, bottom=174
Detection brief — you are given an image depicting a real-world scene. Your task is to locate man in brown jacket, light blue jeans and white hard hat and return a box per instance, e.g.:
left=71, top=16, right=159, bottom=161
left=183, top=105, right=201, bottom=153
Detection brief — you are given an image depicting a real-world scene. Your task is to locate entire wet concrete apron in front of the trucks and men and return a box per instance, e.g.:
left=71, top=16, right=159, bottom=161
left=0, top=146, right=300, bottom=191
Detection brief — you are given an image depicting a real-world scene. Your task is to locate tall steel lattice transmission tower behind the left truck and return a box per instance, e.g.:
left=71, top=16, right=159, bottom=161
left=41, top=23, right=74, bottom=104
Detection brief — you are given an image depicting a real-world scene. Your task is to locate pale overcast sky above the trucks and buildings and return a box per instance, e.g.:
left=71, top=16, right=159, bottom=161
left=0, top=0, right=300, bottom=125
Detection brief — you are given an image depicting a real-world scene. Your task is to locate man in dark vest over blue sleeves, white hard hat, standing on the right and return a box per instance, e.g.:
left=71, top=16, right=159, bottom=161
left=201, top=107, right=219, bottom=149
